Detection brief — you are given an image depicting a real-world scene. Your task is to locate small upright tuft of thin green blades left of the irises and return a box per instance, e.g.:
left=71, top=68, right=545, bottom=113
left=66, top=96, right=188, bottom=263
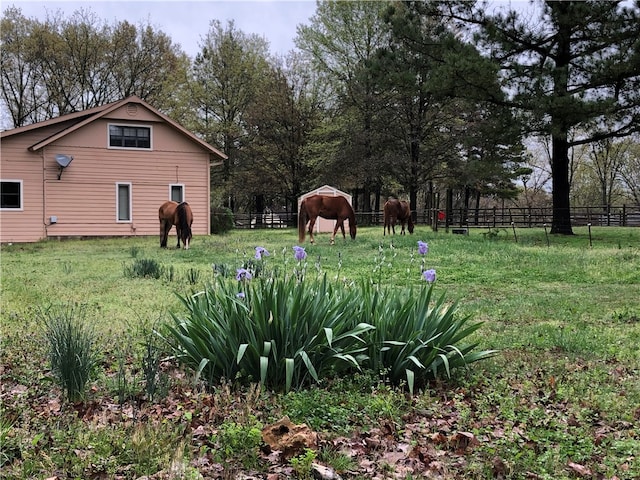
left=38, top=305, right=98, bottom=402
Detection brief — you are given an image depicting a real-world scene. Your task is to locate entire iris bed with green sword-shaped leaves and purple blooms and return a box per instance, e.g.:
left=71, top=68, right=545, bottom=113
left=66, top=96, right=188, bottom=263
left=168, top=241, right=495, bottom=393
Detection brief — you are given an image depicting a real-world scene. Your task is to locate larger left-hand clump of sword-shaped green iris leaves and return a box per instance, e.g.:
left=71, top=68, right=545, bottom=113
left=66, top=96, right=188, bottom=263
left=168, top=269, right=372, bottom=391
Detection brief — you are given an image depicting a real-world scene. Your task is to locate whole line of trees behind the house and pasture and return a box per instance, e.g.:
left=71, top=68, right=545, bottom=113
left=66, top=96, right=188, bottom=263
left=0, top=1, right=640, bottom=233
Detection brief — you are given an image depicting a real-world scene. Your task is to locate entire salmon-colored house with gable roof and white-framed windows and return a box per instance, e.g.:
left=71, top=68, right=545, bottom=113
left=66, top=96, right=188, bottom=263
left=0, top=96, right=226, bottom=243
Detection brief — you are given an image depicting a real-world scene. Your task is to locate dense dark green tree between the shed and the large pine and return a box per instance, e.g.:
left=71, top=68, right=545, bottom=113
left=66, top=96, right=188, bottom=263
left=370, top=2, right=522, bottom=218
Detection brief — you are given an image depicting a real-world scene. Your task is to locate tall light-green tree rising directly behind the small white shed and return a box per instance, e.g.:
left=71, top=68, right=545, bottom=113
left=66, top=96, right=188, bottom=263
left=296, top=1, right=396, bottom=211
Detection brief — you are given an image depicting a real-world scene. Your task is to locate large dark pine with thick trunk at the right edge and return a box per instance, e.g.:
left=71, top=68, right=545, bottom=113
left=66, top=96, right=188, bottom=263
left=449, top=1, right=640, bottom=234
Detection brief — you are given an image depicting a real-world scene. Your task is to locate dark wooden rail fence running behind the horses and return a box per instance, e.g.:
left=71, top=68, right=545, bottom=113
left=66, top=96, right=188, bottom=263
left=225, top=205, right=640, bottom=228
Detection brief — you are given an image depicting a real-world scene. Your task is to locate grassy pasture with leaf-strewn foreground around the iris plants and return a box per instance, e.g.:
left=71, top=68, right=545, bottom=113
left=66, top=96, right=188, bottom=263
left=0, top=225, right=640, bottom=480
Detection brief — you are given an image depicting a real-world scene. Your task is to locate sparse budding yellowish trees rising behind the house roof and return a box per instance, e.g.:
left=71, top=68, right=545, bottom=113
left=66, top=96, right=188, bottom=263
left=0, top=8, right=186, bottom=127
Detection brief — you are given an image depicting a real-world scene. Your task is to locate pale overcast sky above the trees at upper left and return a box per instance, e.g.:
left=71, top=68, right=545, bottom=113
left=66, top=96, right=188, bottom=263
left=2, top=0, right=316, bottom=57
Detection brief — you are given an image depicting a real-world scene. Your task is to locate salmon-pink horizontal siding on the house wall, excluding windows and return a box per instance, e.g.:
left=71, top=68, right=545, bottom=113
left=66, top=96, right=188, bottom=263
left=0, top=96, right=219, bottom=242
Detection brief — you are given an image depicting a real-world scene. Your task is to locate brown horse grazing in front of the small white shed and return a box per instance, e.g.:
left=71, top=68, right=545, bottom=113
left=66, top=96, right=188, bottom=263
left=298, top=195, right=356, bottom=245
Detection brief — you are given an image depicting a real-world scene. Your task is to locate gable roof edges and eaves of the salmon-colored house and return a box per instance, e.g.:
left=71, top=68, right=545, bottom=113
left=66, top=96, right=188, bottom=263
left=0, top=95, right=227, bottom=160
